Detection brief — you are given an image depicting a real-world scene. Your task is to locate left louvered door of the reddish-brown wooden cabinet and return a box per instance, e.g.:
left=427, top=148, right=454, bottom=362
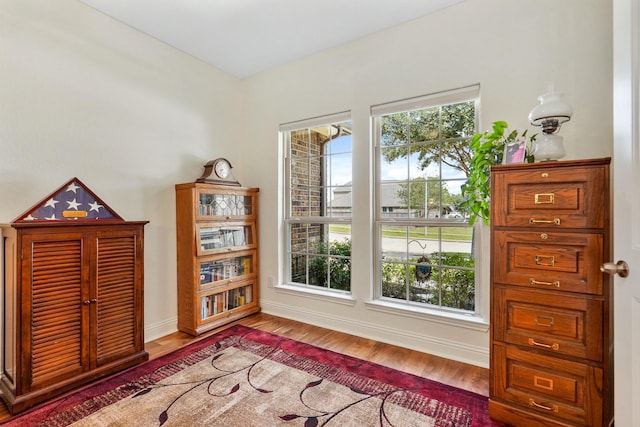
left=21, top=233, right=89, bottom=390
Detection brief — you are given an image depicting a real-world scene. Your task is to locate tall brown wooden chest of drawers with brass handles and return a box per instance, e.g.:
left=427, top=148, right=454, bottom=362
left=489, top=158, right=613, bottom=427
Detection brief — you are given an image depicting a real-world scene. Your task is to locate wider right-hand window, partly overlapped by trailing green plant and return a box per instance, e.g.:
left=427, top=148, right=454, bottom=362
left=372, top=86, right=479, bottom=313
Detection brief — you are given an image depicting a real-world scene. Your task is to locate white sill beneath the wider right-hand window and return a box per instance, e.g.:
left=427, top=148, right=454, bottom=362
left=365, top=300, right=489, bottom=332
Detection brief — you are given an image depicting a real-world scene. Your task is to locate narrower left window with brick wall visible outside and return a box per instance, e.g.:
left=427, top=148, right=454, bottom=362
left=281, top=113, right=352, bottom=292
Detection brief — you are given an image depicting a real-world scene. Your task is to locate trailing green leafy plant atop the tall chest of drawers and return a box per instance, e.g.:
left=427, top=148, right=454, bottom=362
left=460, top=121, right=536, bottom=225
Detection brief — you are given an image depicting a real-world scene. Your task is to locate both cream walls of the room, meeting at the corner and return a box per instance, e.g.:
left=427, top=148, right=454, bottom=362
left=0, top=0, right=612, bottom=366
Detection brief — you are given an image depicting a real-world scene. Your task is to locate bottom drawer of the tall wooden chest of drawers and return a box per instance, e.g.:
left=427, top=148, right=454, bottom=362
left=491, top=344, right=603, bottom=426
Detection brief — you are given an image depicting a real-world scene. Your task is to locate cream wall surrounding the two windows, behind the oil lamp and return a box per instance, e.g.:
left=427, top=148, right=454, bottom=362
left=241, top=0, right=612, bottom=366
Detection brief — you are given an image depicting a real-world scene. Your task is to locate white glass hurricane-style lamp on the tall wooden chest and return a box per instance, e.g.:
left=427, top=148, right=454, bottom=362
left=529, top=91, right=573, bottom=162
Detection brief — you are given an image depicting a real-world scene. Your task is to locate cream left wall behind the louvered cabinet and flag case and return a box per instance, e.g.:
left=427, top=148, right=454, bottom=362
left=0, top=0, right=242, bottom=339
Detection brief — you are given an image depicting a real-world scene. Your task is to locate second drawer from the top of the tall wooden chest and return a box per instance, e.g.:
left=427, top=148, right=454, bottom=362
left=491, top=230, right=604, bottom=295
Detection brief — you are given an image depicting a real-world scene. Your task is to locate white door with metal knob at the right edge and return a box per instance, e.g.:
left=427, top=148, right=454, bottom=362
left=612, top=0, right=640, bottom=427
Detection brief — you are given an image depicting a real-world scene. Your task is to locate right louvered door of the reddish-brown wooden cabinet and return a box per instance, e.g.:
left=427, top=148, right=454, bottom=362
left=91, top=230, right=144, bottom=366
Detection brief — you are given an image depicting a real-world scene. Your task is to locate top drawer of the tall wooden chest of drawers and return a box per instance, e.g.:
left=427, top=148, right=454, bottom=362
left=491, top=165, right=609, bottom=229
